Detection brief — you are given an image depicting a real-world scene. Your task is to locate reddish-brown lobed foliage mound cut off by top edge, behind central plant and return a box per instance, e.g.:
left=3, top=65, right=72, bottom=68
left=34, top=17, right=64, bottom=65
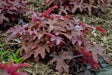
left=44, top=0, right=111, bottom=15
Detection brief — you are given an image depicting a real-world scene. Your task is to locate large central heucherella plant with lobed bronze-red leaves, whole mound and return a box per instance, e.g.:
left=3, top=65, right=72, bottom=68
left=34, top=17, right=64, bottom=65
left=7, top=6, right=111, bottom=73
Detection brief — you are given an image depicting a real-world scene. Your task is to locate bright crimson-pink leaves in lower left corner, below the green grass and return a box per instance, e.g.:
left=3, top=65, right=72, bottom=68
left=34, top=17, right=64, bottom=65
left=0, top=62, right=30, bottom=75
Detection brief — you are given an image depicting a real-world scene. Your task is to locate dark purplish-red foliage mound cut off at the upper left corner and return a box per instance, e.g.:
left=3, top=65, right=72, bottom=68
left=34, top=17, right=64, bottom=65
left=0, top=0, right=27, bottom=27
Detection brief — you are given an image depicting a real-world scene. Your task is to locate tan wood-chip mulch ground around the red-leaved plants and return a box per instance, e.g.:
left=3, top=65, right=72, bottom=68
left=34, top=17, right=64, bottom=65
left=0, top=0, right=112, bottom=75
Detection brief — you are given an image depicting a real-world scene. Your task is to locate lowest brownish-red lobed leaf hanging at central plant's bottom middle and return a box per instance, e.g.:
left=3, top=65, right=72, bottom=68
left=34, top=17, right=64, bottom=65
left=50, top=51, right=71, bottom=73
